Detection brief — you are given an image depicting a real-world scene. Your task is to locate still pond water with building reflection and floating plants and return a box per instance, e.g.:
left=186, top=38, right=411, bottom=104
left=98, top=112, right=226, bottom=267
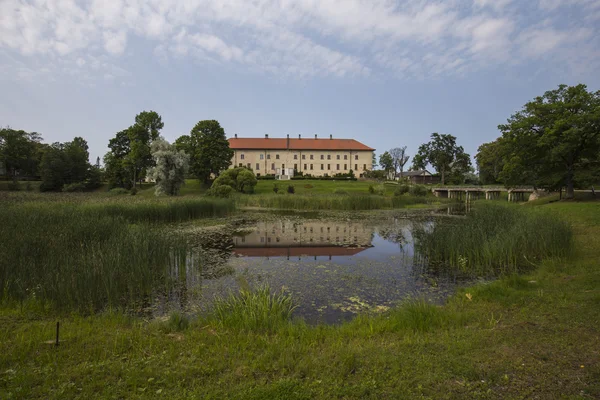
left=155, top=211, right=472, bottom=323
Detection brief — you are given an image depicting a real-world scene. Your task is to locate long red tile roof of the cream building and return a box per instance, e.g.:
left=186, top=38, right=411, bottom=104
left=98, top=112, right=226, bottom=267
left=229, top=138, right=375, bottom=151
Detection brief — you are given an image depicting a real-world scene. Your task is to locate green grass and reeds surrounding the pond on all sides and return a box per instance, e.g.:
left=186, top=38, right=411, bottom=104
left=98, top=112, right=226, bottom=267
left=0, top=186, right=600, bottom=399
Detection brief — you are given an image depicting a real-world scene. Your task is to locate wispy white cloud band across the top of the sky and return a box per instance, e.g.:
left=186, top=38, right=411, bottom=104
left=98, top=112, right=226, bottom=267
left=0, top=0, right=600, bottom=78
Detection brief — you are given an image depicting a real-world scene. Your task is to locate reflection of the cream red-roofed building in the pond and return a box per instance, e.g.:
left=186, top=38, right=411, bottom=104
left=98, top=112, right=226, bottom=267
left=233, top=221, right=375, bottom=259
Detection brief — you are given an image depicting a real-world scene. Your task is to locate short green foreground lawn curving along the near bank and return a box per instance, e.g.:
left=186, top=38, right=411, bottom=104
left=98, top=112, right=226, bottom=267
left=0, top=203, right=600, bottom=399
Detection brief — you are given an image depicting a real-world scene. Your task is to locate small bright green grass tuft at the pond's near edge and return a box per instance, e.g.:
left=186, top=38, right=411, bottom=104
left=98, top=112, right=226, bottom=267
left=211, top=285, right=296, bottom=332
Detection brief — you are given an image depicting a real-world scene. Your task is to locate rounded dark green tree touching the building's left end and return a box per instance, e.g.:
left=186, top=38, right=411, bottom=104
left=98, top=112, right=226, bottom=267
left=175, top=120, right=233, bottom=183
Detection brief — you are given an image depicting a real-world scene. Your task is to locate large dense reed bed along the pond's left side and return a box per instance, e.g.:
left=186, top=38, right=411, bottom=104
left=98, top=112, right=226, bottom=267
left=0, top=199, right=233, bottom=312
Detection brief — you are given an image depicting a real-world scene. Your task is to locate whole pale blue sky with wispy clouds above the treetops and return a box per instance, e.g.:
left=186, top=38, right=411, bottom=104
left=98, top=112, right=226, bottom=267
left=0, top=0, right=600, bottom=164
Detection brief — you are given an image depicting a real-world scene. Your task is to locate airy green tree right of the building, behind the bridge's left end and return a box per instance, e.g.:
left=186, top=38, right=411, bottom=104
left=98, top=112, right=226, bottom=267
left=413, top=133, right=471, bottom=185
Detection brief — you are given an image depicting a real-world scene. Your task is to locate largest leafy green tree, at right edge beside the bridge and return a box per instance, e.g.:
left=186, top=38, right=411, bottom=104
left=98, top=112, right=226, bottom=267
left=498, top=84, right=600, bottom=198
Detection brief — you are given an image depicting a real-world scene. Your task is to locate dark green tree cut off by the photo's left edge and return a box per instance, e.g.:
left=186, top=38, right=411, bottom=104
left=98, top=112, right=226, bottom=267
left=0, top=127, right=42, bottom=181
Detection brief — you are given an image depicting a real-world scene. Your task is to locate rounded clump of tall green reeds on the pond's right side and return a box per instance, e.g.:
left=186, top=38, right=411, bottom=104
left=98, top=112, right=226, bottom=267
left=415, top=203, right=572, bottom=276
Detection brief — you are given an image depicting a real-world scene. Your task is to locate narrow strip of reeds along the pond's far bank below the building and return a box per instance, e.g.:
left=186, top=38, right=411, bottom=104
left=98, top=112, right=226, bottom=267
left=236, top=194, right=437, bottom=210
